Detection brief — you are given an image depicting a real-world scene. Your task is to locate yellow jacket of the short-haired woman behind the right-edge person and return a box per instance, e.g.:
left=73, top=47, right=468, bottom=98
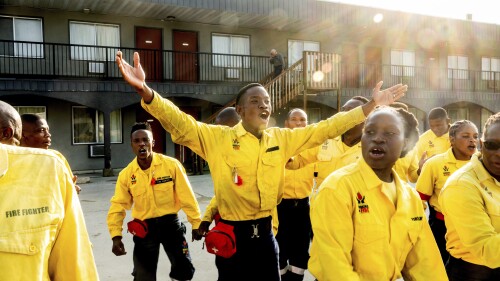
left=416, top=148, right=469, bottom=212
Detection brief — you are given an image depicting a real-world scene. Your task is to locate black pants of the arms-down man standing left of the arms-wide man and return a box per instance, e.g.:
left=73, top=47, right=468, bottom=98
left=133, top=214, right=194, bottom=281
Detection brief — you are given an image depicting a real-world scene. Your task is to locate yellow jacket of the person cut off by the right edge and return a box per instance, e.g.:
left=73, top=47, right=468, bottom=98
left=439, top=154, right=500, bottom=268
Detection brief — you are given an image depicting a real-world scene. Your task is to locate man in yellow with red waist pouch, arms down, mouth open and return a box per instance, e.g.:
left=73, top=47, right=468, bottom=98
left=108, top=123, right=201, bottom=281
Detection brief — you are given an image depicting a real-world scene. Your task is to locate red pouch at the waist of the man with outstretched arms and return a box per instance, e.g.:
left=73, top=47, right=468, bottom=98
left=205, top=221, right=236, bottom=258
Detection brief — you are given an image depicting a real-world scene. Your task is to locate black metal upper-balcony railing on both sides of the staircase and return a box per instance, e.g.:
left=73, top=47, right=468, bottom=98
left=0, top=40, right=500, bottom=93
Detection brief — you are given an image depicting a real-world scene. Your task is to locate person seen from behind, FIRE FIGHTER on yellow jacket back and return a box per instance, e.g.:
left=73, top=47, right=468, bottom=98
left=0, top=101, right=99, bottom=281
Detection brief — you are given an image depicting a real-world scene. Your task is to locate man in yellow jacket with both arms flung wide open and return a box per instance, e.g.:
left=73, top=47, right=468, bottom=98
left=116, top=52, right=407, bottom=281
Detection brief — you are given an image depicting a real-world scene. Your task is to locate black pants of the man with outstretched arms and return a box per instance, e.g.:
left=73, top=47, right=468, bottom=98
left=215, top=217, right=280, bottom=281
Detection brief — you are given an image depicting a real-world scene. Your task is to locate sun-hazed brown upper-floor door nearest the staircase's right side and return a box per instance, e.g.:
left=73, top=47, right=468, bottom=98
left=342, top=44, right=359, bottom=88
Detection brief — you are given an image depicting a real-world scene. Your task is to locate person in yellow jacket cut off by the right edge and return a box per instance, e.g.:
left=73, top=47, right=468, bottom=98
left=439, top=113, right=500, bottom=281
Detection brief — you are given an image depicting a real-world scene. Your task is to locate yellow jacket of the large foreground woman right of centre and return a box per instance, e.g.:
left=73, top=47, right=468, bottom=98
left=308, top=159, right=448, bottom=281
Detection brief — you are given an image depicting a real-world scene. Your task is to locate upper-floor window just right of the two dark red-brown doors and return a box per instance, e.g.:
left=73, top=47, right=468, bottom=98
left=212, top=33, right=250, bottom=68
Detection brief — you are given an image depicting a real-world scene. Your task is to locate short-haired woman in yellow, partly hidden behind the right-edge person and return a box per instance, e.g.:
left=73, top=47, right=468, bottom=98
left=416, top=120, right=479, bottom=263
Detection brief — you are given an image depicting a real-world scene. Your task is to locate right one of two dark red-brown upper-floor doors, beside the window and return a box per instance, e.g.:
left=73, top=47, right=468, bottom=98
left=174, top=30, right=198, bottom=82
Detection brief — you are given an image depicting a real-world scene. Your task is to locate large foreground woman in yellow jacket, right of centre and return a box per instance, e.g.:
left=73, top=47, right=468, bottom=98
left=309, top=107, right=448, bottom=281
